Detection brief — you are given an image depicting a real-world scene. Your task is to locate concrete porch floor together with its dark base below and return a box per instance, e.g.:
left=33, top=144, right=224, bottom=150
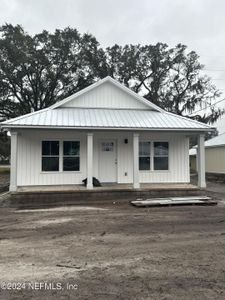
left=6, top=183, right=205, bottom=209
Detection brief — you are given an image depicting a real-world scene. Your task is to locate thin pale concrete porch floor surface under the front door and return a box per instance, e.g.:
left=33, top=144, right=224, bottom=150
left=16, top=183, right=199, bottom=193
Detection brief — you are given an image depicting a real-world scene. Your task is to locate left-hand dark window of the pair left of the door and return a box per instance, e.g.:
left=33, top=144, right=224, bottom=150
left=42, top=141, right=59, bottom=172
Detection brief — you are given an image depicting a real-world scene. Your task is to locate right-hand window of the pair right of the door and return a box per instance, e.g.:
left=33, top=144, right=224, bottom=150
left=154, top=142, right=169, bottom=170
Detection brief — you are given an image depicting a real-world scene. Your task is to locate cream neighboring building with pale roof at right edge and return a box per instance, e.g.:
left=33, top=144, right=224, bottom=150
left=189, top=133, right=225, bottom=174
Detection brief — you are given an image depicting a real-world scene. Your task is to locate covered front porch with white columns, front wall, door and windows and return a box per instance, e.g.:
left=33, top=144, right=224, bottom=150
left=10, top=130, right=206, bottom=192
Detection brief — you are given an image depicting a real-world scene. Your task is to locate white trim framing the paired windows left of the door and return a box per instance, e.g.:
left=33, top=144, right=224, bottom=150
left=40, top=137, right=81, bottom=174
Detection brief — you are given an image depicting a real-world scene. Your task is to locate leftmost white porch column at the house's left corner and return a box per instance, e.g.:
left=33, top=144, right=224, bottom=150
left=9, top=131, right=18, bottom=192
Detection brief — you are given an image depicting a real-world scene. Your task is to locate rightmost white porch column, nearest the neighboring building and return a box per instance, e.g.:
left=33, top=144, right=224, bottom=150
left=196, top=134, right=206, bottom=188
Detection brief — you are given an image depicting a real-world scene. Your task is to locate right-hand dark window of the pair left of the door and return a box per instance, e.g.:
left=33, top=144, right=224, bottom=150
left=63, top=141, right=80, bottom=171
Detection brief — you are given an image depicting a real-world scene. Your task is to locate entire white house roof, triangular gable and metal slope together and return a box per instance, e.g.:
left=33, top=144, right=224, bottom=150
left=1, top=77, right=214, bottom=131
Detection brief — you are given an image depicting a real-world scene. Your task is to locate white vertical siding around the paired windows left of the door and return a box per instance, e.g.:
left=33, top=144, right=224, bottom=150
left=17, top=130, right=86, bottom=186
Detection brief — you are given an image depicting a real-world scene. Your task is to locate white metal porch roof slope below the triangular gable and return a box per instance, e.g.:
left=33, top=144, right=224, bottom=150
left=1, top=108, right=212, bottom=131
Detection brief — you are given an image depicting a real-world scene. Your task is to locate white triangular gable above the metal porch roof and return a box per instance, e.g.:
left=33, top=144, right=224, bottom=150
left=51, top=76, right=162, bottom=111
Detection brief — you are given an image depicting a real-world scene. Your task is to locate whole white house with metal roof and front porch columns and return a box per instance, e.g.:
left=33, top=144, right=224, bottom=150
left=1, top=77, right=213, bottom=191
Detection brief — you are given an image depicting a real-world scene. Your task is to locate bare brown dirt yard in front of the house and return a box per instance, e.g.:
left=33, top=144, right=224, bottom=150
left=0, top=197, right=225, bottom=300
